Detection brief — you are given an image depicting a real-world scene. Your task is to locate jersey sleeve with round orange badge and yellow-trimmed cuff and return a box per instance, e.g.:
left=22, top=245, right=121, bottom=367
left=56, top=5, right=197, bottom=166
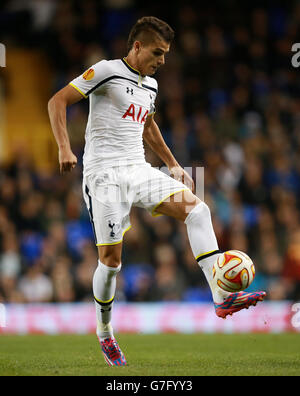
left=69, top=60, right=111, bottom=98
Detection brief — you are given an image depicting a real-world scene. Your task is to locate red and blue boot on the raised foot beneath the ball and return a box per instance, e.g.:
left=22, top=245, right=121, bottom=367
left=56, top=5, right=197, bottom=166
left=215, top=292, right=266, bottom=319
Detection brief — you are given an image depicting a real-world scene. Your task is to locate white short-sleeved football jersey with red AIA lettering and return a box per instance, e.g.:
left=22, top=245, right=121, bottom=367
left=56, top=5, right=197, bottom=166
left=70, top=59, right=157, bottom=176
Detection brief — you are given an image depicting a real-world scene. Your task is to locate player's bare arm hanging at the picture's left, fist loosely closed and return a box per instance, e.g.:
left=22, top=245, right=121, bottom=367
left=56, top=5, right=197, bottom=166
left=48, top=85, right=83, bottom=173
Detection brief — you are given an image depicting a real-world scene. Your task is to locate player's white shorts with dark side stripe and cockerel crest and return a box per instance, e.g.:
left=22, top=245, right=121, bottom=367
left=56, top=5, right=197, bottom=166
left=82, top=163, right=188, bottom=246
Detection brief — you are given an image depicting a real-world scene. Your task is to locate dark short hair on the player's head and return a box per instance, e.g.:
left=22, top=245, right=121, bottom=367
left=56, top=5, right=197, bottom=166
left=127, top=16, right=174, bottom=52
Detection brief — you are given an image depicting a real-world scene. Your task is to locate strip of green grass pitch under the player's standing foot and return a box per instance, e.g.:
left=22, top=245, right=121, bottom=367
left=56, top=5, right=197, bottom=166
left=0, top=334, right=300, bottom=376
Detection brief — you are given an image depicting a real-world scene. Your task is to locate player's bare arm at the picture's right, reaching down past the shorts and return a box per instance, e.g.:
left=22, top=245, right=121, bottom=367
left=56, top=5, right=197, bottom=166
left=143, top=114, right=194, bottom=191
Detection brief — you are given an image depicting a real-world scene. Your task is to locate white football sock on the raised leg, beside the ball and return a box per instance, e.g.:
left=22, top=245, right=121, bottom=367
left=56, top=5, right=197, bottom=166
left=185, top=202, right=230, bottom=304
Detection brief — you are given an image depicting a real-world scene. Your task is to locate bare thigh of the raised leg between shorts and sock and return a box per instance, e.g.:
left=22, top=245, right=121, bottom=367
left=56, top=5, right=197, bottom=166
left=155, top=190, right=201, bottom=221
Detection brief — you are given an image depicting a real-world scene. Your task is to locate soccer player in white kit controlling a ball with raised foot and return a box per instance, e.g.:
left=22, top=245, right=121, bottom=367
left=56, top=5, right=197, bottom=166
left=48, top=17, right=265, bottom=366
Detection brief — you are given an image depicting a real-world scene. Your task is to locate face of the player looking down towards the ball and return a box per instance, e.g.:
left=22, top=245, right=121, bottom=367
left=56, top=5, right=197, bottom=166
left=137, top=39, right=170, bottom=76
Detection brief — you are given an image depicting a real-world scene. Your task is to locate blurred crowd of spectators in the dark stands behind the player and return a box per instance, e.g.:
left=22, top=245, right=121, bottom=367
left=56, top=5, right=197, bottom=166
left=0, top=0, right=300, bottom=302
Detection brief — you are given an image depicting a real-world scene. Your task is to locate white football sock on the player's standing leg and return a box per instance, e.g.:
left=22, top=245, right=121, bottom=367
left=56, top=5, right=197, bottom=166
left=93, top=260, right=121, bottom=338
